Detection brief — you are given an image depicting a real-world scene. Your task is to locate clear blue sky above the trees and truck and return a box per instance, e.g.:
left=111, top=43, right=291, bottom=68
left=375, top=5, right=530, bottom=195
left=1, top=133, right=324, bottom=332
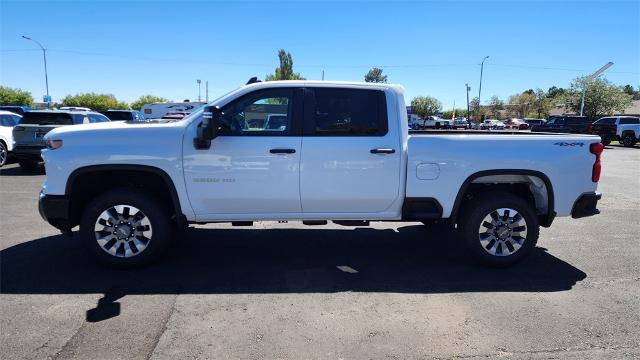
left=0, top=0, right=640, bottom=109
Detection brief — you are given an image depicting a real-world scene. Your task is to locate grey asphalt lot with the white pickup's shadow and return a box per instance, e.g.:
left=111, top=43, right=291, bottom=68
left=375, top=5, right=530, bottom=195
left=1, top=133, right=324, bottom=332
left=0, top=146, right=640, bottom=359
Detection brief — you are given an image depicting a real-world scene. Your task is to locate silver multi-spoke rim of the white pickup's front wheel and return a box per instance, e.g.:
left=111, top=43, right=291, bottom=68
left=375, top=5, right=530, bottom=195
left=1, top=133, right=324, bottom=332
left=94, top=205, right=152, bottom=258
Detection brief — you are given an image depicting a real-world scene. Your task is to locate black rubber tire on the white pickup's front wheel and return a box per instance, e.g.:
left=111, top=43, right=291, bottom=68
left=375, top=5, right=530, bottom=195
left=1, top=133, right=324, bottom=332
left=80, top=189, right=175, bottom=268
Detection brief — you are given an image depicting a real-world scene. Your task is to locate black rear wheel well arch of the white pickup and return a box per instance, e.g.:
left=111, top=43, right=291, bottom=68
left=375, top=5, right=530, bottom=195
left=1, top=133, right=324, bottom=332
left=451, top=172, right=555, bottom=227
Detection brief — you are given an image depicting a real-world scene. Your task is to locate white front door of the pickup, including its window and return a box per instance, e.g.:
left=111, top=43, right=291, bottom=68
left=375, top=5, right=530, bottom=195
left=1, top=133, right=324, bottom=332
left=184, top=88, right=302, bottom=221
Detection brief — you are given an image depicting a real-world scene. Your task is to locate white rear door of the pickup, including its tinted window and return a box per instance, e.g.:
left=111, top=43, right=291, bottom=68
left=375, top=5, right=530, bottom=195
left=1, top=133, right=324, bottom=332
left=300, top=87, right=402, bottom=214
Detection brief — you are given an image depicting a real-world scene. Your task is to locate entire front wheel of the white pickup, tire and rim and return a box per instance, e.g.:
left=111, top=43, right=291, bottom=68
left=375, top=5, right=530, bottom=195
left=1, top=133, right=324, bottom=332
left=80, top=189, right=173, bottom=268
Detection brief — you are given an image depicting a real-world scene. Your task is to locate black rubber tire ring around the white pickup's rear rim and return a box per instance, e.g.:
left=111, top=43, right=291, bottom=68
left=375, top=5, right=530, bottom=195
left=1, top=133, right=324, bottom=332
left=461, top=192, right=540, bottom=267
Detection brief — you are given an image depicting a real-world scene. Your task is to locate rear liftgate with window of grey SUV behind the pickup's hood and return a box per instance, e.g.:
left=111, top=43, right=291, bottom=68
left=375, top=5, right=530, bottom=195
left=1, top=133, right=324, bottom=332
left=13, top=111, right=73, bottom=148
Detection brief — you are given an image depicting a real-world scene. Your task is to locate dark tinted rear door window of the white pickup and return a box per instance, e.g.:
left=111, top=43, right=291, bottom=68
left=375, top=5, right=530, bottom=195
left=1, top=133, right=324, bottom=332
left=305, top=88, right=388, bottom=136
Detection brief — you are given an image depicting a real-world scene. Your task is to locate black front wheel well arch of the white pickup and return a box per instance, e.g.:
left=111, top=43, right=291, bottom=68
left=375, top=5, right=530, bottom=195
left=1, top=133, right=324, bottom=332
left=67, top=168, right=183, bottom=226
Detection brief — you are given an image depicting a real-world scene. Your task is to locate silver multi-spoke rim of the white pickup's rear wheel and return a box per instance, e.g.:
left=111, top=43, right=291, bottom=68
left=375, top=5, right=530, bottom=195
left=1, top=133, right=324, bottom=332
left=478, top=208, right=527, bottom=256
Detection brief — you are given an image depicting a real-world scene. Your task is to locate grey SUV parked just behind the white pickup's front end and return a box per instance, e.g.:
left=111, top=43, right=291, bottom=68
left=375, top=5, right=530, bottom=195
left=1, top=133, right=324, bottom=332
left=13, top=110, right=109, bottom=170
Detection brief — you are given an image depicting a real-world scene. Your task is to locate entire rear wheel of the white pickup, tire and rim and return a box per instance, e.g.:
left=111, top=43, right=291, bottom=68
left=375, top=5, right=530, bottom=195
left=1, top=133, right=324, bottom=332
left=458, top=191, right=540, bottom=267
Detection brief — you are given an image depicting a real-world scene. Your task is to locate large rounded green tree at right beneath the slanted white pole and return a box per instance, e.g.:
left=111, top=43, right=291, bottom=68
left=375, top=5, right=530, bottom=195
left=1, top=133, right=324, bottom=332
left=566, top=77, right=633, bottom=119
